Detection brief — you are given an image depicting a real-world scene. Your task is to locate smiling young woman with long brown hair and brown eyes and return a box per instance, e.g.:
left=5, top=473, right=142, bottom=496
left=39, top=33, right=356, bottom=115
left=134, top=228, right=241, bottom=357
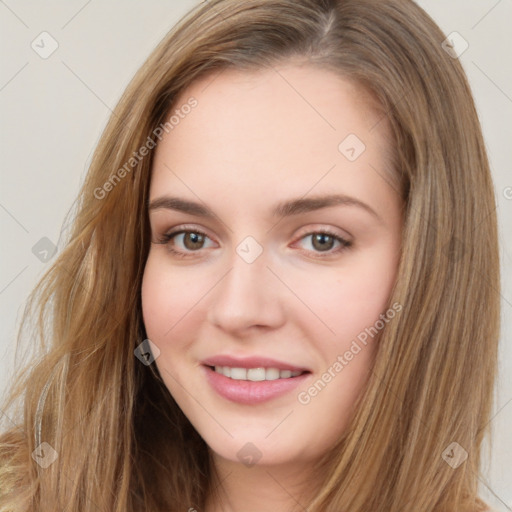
left=0, top=0, right=499, bottom=512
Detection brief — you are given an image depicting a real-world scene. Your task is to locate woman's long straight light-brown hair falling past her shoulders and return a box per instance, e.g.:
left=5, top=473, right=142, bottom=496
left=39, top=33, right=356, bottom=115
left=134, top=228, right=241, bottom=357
left=0, top=0, right=500, bottom=512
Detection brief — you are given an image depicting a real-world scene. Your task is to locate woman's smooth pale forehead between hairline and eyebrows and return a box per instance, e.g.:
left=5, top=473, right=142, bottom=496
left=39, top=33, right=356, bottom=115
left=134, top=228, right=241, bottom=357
left=150, top=65, right=390, bottom=206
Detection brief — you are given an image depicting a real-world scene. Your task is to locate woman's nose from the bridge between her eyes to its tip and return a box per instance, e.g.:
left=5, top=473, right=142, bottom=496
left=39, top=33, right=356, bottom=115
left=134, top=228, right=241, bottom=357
left=209, top=237, right=282, bottom=330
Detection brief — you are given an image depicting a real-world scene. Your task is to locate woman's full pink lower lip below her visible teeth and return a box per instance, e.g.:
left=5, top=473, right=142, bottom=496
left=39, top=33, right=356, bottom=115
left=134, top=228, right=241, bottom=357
left=203, top=366, right=310, bottom=405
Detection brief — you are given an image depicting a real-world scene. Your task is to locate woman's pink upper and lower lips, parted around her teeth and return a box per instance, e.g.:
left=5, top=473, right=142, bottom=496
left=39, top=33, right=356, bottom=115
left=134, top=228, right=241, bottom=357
left=201, top=356, right=311, bottom=405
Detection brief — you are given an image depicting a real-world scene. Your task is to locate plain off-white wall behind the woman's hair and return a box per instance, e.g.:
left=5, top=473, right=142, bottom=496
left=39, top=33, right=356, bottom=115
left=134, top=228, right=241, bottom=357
left=0, top=0, right=512, bottom=511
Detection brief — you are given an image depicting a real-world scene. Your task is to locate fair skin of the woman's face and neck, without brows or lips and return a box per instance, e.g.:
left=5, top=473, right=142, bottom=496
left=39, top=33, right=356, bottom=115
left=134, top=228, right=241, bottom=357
left=142, top=62, right=402, bottom=512
